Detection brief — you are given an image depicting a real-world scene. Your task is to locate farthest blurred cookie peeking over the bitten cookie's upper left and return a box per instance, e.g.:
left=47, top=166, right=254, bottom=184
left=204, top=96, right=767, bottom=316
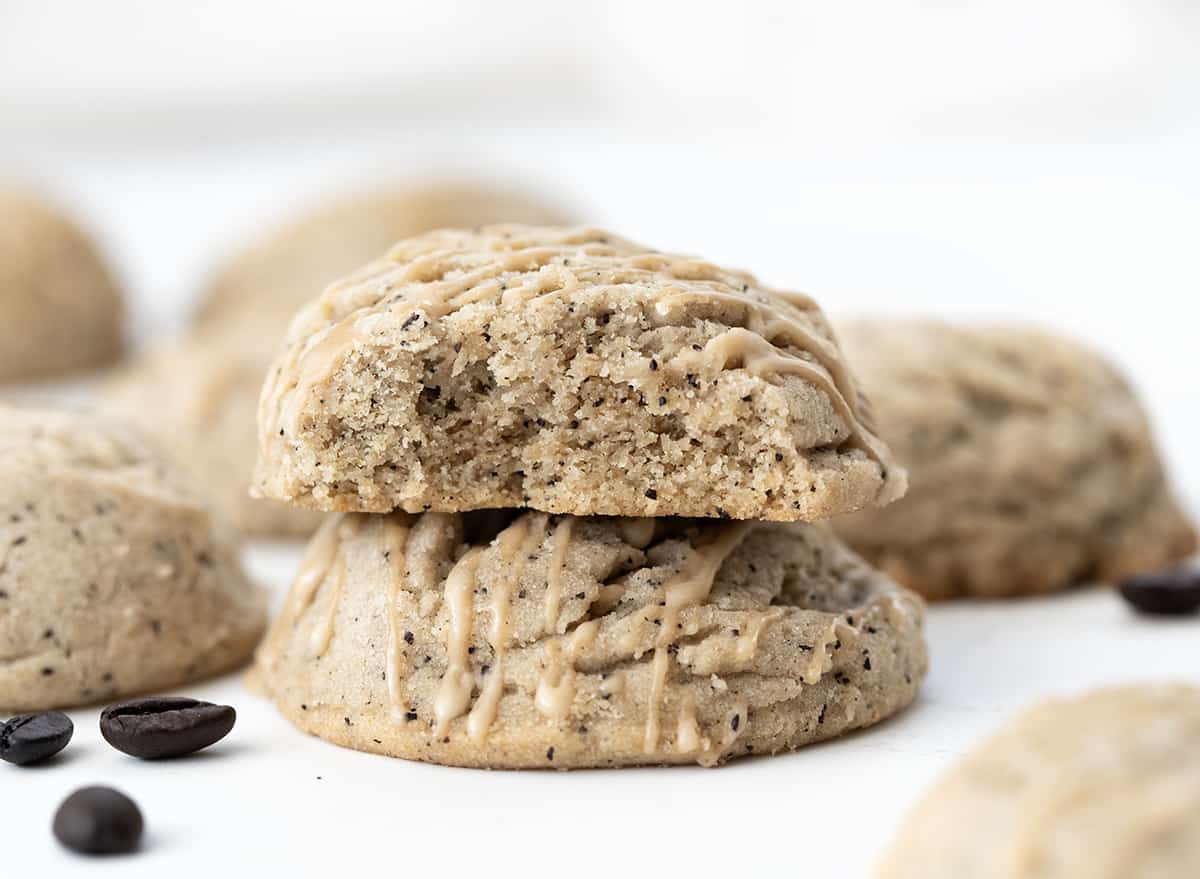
left=196, top=183, right=564, bottom=329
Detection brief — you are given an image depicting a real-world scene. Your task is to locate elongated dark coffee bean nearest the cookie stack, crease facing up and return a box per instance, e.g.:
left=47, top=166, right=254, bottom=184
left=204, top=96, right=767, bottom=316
left=100, top=696, right=238, bottom=760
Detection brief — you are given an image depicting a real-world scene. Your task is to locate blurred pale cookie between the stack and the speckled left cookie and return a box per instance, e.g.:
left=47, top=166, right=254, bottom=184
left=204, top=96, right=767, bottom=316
left=103, top=319, right=320, bottom=538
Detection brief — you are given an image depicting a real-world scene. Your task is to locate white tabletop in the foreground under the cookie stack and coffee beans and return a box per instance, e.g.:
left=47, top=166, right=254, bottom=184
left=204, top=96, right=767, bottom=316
left=9, top=546, right=1200, bottom=879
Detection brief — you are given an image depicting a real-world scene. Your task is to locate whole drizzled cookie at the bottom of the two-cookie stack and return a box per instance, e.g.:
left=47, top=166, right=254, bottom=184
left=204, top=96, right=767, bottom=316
left=258, top=512, right=926, bottom=769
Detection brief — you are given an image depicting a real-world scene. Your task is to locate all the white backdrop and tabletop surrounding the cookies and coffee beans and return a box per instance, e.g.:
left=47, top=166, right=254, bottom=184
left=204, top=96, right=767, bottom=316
left=0, top=0, right=1200, bottom=877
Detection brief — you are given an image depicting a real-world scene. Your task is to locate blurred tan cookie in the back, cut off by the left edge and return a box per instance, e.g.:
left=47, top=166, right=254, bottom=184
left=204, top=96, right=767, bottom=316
left=0, top=190, right=124, bottom=381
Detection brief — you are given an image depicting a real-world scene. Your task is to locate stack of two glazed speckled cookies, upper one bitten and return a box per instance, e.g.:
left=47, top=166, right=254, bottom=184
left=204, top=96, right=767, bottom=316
left=256, top=226, right=926, bottom=767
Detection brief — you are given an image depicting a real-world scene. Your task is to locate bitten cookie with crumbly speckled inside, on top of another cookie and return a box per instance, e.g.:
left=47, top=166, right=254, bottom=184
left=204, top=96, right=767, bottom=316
left=256, top=226, right=906, bottom=521
